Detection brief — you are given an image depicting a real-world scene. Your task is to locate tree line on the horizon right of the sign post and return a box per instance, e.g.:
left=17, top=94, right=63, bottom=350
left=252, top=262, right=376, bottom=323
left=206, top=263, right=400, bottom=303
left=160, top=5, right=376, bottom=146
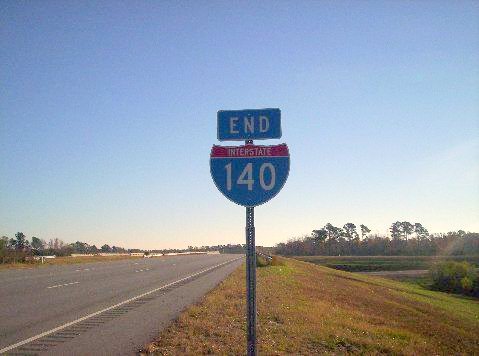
left=275, top=221, right=479, bottom=256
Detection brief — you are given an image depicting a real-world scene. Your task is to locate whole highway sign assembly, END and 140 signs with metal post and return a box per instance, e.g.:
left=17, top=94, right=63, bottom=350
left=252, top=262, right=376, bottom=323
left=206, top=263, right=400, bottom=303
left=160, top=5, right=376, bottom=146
left=210, top=109, right=290, bottom=356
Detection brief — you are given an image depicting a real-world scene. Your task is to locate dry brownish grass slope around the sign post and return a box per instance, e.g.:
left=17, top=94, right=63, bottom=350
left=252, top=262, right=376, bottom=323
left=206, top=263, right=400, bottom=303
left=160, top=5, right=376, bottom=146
left=147, top=259, right=479, bottom=355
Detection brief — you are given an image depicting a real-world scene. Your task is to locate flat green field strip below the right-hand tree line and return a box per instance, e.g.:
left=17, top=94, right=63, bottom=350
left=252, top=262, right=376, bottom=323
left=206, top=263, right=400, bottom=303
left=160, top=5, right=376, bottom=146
left=294, top=256, right=479, bottom=272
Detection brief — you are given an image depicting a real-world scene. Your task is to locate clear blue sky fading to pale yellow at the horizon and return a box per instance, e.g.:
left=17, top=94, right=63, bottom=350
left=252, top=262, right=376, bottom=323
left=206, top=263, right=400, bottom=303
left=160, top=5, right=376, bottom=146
left=0, top=1, right=479, bottom=249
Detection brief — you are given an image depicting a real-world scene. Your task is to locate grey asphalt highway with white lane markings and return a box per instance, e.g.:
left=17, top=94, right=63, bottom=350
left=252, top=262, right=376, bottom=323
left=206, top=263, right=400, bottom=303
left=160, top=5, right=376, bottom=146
left=0, top=255, right=243, bottom=355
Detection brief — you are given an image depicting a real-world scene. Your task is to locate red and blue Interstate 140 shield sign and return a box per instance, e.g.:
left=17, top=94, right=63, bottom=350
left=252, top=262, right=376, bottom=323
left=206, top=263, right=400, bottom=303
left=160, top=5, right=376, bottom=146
left=210, top=144, right=289, bottom=207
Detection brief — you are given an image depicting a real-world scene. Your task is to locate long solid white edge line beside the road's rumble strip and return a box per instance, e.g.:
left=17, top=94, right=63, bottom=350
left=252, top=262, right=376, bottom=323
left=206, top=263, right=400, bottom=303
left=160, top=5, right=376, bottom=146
left=0, top=256, right=243, bottom=354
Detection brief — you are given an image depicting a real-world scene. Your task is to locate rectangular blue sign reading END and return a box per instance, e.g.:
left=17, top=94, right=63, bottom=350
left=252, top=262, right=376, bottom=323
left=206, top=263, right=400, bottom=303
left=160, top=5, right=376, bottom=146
left=218, top=109, right=281, bottom=141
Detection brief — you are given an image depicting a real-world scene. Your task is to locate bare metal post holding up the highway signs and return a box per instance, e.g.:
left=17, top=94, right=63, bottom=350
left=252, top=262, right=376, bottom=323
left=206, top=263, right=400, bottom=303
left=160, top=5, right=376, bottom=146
left=246, top=140, right=257, bottom=356
